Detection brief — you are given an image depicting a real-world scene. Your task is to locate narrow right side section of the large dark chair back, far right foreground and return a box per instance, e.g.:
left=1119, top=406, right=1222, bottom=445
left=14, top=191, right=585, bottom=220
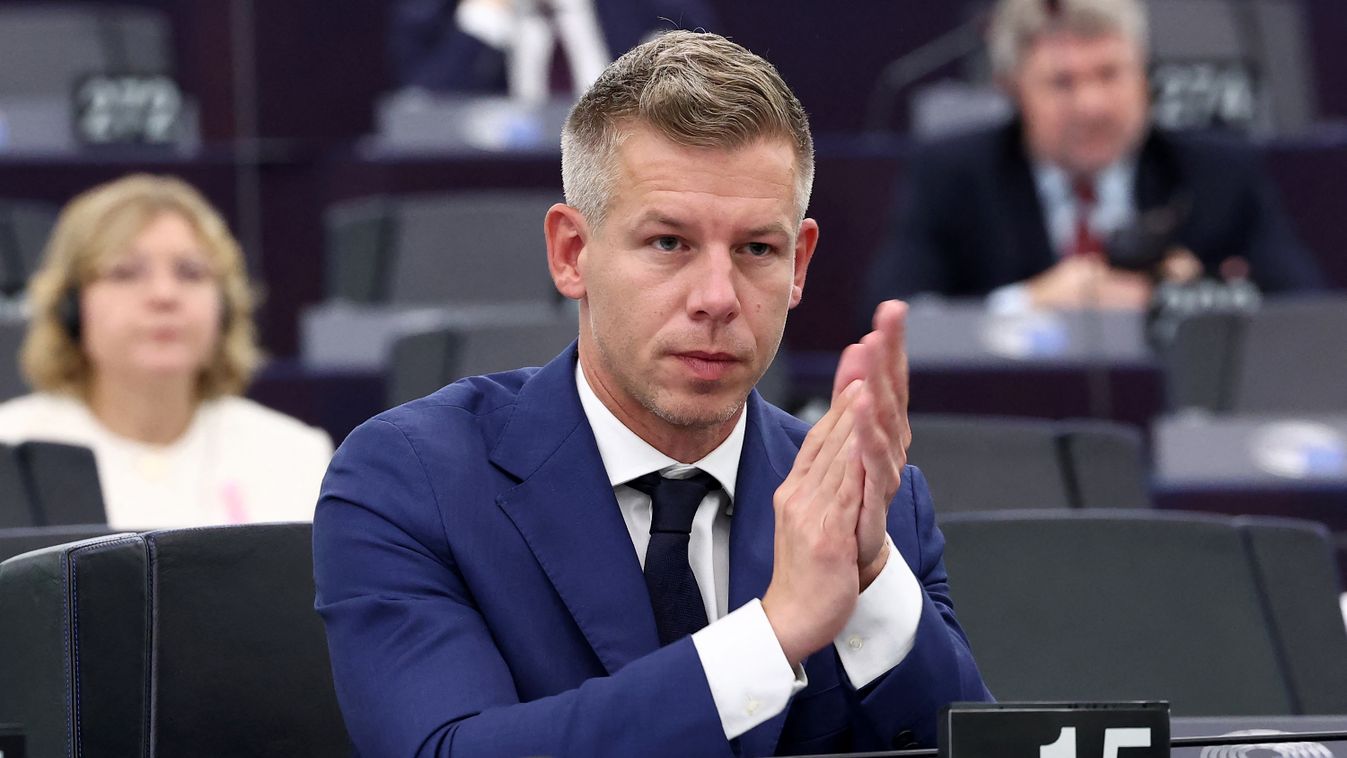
left=1235, top=517, right=1347, bottom=714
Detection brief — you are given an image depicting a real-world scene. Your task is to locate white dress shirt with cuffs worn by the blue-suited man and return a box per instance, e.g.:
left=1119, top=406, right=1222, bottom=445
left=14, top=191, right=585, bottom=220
left=575, top=364, right=921, bottom=739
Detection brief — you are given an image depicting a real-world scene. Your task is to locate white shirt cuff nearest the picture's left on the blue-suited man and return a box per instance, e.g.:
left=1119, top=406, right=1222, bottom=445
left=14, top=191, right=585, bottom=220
left=692, top=603, right=802, bottom=739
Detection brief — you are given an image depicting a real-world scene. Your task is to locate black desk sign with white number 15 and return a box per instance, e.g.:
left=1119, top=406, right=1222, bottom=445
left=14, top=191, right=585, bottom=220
left=940, top=703, right=1169, bottom=758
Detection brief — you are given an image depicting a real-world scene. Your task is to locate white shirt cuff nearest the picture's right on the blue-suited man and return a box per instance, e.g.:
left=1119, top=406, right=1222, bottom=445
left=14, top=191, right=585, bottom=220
left=832, top=537, right=921, bottom=689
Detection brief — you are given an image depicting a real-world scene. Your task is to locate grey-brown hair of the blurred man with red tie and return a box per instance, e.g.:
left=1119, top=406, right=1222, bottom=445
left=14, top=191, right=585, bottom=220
left=987, top=0, right=1149, bottom=77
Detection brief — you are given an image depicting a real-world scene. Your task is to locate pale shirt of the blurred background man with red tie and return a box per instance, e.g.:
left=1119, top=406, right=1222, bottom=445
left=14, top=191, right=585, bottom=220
left=987, top=156, right=1137, bottom=314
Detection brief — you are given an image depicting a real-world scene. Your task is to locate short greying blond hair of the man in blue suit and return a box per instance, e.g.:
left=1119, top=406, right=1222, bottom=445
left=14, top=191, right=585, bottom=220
left=562, top=31, right=814, bottom=228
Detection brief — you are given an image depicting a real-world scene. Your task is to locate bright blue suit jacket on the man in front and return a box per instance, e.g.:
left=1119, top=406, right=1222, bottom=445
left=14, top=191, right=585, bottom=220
left=314, top=345, right=989, bottom=757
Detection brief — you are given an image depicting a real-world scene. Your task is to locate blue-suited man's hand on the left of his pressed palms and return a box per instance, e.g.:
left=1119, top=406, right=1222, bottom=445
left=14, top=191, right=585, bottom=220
left=762, top=380, right=865, bottom=666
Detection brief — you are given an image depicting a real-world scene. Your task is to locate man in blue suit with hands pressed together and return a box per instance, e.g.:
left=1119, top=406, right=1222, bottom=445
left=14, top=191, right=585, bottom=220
left=314, top=32, right=989, bottom=757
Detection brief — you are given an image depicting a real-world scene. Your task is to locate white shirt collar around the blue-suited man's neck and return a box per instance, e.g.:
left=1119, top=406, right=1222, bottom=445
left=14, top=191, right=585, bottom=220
left=575, top=361, right=748, bottom=501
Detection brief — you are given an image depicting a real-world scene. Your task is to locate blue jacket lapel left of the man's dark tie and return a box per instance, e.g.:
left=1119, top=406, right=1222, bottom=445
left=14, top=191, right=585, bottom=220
left=492, top=345, right=659, bottom=673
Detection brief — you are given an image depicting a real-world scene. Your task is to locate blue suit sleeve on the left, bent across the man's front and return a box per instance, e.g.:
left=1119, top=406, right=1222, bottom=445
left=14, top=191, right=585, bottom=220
left=314, top=419, right=730, bottom=757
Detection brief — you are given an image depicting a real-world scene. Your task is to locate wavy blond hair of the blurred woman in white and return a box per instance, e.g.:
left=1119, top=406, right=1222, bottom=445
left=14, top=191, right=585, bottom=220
left=19, top=174, right=261, bottom=400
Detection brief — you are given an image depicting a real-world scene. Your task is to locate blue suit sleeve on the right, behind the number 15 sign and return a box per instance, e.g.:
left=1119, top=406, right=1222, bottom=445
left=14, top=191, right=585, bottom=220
left=857, top=466, right=991, bottom=750
